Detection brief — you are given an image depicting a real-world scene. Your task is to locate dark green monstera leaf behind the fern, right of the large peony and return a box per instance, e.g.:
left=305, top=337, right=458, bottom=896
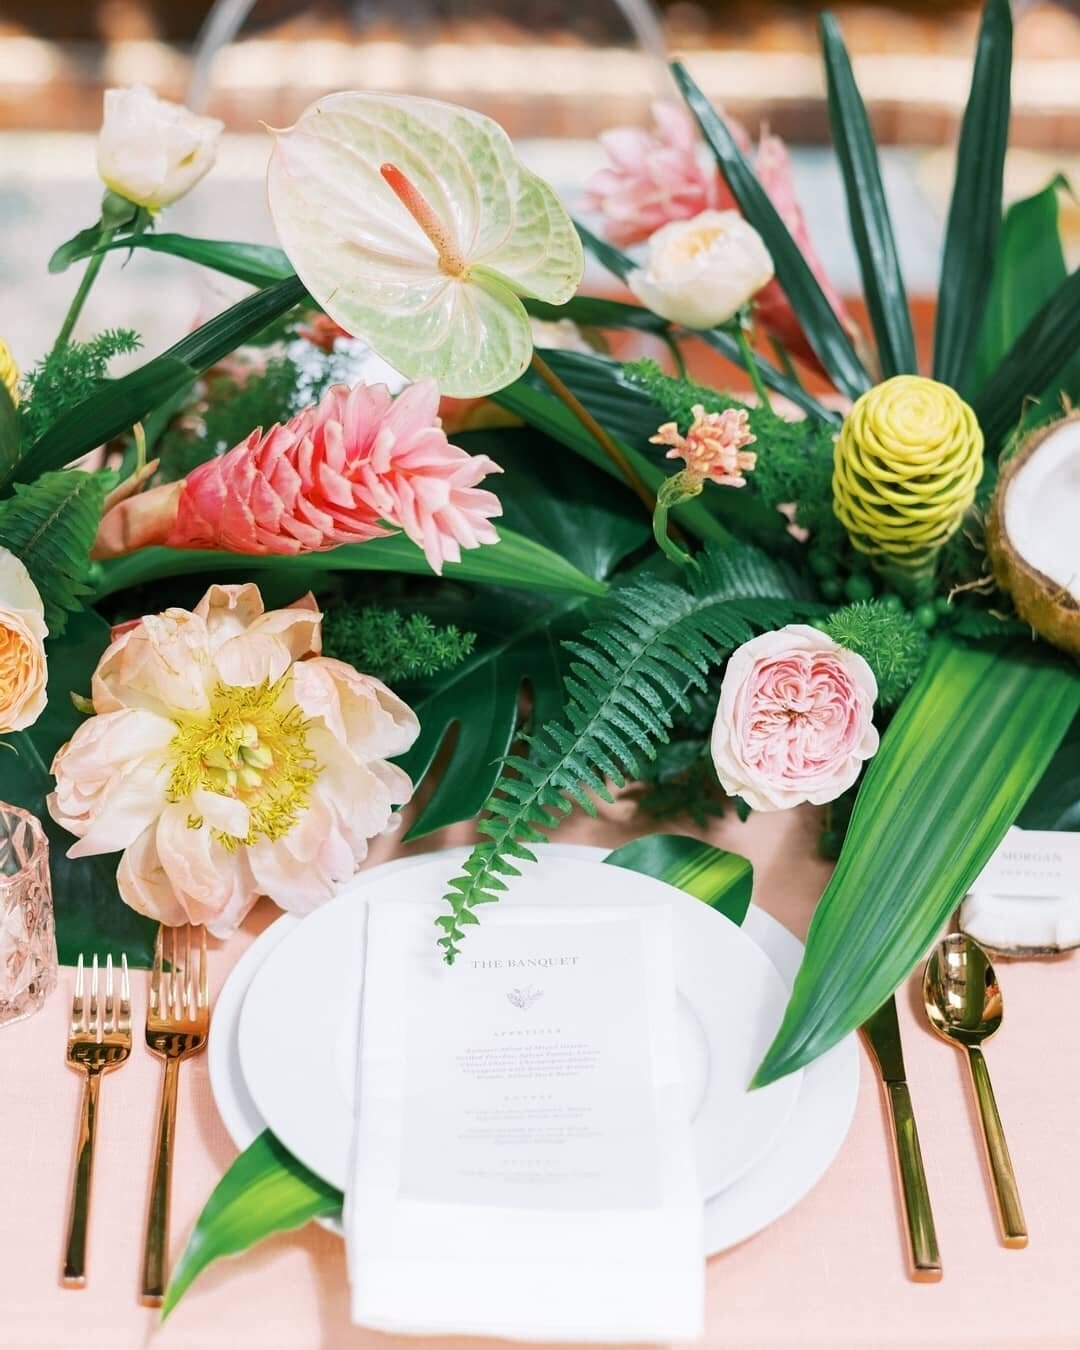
left=401, top=431, right=648, bottom=838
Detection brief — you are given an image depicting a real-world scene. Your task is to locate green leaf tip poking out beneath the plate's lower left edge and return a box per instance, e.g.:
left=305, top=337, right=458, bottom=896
left=161, top=1130, right=343, bottom=1322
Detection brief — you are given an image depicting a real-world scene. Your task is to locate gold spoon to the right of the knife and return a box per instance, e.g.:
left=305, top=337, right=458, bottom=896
left=922, top=933, right=1027, bottom=1247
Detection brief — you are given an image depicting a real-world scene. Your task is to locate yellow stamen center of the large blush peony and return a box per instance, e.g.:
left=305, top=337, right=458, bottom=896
left=166, top=675, right=319, bottom=848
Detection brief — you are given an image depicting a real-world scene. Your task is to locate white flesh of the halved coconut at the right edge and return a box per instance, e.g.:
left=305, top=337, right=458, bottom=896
left=1004, top=419, right=1080, bottom=602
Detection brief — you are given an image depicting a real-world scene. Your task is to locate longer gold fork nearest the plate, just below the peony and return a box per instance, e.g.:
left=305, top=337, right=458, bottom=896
left=142, top=923, right=211, bottom=1308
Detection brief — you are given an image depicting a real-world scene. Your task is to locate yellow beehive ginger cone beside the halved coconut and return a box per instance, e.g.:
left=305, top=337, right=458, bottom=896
left=833, top=375, right=983, bottom=574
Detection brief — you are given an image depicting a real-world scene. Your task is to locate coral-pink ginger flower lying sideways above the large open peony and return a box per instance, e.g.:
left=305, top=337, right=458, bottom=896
left=95, top=379, right=502, bottom=574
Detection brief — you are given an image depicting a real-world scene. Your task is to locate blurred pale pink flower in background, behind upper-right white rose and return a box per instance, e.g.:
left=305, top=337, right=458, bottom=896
left=586, top=103, right=732, bottom=248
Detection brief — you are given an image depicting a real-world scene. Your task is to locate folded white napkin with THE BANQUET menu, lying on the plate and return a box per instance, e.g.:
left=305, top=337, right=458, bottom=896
left=346, top=902, right=703, bottom=1342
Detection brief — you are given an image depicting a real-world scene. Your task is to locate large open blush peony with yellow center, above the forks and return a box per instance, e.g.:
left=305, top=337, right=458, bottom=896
left=49, top=585, right=419, bottom=937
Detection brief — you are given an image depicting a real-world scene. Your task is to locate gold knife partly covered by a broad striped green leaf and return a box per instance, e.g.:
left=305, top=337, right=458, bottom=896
left=863, top=996, right=941, bottom=1283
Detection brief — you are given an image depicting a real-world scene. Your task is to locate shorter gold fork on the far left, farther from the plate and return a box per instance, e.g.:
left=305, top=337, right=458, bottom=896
left=61, top=953, right=131, bottom=1289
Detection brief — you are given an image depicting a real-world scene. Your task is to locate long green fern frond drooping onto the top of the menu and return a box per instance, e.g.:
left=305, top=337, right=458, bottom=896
left=437, top=545, right=814, bottom=964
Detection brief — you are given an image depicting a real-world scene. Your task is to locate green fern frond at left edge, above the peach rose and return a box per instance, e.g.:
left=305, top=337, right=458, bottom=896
left=0, top=468, right=109, bottom=636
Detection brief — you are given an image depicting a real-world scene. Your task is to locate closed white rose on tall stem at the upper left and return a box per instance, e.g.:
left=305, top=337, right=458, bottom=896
left=97, top=85, right=224, bottom=211
